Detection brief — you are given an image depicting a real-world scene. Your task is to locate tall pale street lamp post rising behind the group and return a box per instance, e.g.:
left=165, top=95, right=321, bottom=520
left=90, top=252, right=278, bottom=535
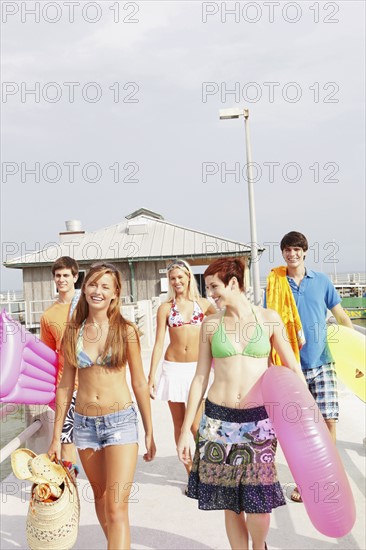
left=220, top=108, right=261, bottom=305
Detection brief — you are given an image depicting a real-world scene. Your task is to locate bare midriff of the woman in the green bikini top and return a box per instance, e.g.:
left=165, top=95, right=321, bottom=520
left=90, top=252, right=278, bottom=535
left=207, top=355, right=268, bottom=409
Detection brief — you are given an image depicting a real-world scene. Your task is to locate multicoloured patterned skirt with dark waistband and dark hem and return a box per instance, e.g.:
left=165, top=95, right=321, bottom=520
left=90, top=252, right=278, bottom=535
left=188, top=399, right=285, bottom=514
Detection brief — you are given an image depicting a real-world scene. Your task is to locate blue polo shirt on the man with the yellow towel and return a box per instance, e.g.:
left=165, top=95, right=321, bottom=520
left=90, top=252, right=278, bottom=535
left=287, top=269, right=341, bottom=370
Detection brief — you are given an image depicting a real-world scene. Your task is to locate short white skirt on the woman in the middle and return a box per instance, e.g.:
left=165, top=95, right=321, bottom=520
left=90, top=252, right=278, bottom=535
left=156, top=360, right=197, bottom=403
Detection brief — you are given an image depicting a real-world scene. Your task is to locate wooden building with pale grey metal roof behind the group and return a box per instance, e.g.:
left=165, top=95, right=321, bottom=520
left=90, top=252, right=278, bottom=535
left=4, top=208, right=263, bottom=322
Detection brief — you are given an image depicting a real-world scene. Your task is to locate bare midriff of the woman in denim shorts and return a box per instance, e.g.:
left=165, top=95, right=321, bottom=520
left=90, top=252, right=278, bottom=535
left=75, top=365, right=132, bottom=416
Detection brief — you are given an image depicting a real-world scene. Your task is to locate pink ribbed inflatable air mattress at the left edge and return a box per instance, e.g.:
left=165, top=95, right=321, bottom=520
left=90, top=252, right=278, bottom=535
left=0, top=309, right=58, bottom=405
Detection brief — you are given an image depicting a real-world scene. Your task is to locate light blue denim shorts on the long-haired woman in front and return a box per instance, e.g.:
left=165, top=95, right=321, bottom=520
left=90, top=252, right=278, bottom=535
left=74, top=405, right=139, bottom=451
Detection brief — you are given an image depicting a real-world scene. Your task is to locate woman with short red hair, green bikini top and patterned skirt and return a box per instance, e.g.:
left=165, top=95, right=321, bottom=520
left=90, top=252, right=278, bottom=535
left=178, top=258, right=303, bottom=550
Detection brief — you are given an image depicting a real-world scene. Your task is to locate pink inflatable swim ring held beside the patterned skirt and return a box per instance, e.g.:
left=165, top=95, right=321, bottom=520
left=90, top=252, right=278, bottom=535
left=262, top=366, right=356, bottom=538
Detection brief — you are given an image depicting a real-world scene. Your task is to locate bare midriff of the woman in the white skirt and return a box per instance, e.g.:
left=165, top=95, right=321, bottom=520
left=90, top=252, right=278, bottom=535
left=164, top=325, right=200, bottom=363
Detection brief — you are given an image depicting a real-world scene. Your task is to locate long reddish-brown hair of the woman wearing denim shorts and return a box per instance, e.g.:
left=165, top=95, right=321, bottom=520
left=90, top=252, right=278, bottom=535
left=62, top=263, right=140, bottom=367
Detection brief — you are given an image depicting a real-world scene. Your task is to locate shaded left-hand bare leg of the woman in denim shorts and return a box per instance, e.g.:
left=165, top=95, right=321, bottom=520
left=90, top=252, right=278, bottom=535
left=79, top=449, right=108, bottom=538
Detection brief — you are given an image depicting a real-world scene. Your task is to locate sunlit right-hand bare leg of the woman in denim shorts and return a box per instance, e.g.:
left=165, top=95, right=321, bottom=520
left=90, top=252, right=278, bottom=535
left=103, top=443, right=138, bottom=550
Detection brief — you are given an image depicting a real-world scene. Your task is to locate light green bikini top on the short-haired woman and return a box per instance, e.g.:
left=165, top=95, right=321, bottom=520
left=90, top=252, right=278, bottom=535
left=211, top=308, right=271, bottom=359
